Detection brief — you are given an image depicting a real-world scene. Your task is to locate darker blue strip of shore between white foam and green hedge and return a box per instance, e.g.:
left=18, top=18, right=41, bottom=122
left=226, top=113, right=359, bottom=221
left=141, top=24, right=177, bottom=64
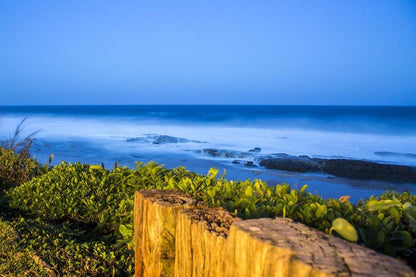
left=28, top=139, right=416, bottom=202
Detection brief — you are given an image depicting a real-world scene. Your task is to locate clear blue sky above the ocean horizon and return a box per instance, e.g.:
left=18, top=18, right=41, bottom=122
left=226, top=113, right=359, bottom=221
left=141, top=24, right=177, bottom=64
left=0, top=0, right=416, bottom=105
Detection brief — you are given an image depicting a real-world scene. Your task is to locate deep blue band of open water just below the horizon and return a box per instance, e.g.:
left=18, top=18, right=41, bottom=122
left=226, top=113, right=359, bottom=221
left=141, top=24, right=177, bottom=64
left=0, top=105, right=416, bottom=134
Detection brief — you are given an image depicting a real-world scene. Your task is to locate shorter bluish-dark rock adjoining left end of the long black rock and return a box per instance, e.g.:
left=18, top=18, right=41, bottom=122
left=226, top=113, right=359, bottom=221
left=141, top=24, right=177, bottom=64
left=260, top=153, right=321, bottom=172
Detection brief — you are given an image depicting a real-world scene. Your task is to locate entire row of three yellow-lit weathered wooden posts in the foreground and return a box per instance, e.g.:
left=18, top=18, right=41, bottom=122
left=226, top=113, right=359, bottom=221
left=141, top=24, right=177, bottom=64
left=134, top=190, right=415, bottom=277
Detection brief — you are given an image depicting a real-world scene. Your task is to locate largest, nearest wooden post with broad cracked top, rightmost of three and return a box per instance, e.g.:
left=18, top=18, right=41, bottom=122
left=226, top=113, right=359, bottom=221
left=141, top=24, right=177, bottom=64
left=224, top=218, right=414, bottom=277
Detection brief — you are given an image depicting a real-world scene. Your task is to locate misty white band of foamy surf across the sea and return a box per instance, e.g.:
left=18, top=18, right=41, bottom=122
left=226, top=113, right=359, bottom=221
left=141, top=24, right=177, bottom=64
left=0, top=115, right=416, bottom=165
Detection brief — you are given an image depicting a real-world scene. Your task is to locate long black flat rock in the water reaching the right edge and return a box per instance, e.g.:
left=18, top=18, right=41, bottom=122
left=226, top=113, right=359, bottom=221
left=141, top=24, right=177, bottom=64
left=314, top=159, right=416, bottom=183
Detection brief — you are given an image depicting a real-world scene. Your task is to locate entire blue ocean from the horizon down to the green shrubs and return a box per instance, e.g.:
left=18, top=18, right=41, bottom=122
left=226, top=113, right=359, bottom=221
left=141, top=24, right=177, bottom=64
left=0, top=105, right=416, bottom=201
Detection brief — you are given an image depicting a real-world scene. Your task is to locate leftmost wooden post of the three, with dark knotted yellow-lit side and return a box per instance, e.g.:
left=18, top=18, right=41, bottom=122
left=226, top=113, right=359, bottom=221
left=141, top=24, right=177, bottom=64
left=134, top=190, right=193, bottom=276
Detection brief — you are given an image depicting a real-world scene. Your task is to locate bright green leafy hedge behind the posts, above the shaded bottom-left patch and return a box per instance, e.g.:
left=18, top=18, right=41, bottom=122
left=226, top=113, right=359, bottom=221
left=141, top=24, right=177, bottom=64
left=7, top=160, right=416, bottom=274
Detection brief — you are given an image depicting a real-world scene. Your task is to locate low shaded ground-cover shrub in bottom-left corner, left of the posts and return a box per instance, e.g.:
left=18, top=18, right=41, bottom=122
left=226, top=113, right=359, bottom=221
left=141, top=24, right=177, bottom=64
left=11, top=218, right=134, bottom=276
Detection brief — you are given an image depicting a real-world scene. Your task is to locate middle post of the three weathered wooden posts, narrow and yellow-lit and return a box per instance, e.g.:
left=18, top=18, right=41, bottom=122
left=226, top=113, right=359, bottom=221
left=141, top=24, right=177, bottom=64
left=175, top=202, right=239, bottom=277
